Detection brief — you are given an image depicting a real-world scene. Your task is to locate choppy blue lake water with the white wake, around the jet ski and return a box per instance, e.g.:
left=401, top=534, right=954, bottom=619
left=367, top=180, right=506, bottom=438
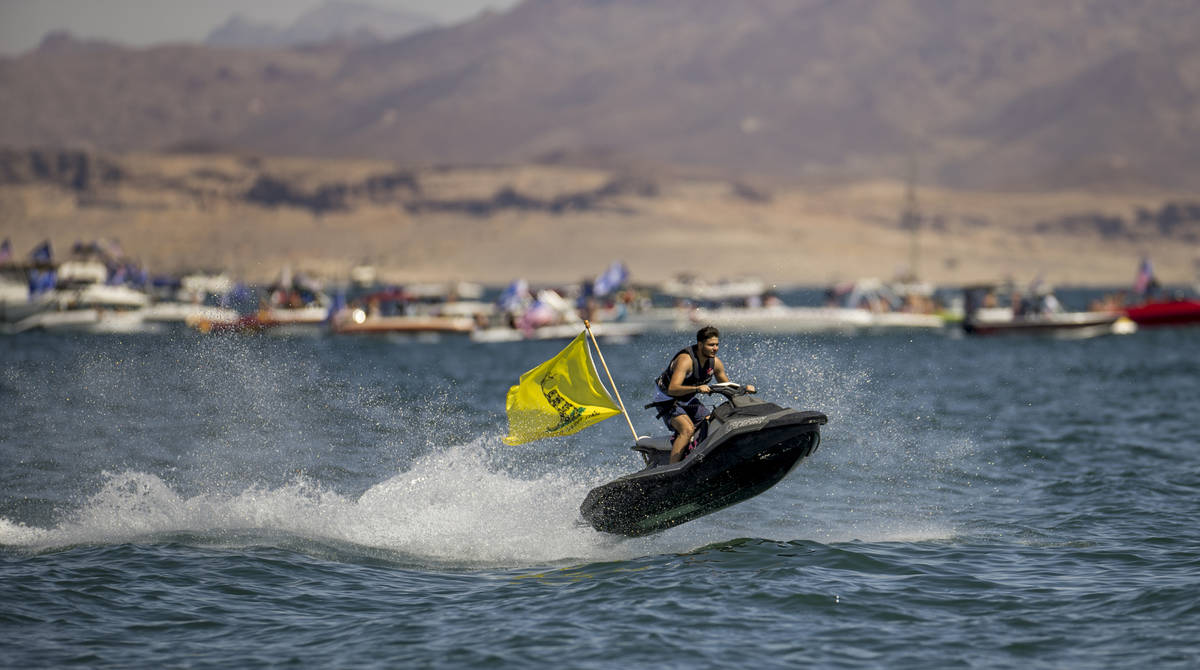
left=0, top=329, right=1200, bottom=669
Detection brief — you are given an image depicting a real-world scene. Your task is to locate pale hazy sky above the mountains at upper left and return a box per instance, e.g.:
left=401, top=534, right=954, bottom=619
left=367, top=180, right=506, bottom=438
left=0, top=0, right=517, bottom=55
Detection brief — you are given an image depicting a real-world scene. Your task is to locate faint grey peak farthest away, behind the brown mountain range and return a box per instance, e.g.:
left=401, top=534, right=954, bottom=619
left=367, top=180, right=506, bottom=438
left=204, top=0, right=437, bottom=48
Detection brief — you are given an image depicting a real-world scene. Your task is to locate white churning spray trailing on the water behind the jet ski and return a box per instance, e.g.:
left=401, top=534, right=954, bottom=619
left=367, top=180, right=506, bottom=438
left=0, top=445, right=636, bottom=566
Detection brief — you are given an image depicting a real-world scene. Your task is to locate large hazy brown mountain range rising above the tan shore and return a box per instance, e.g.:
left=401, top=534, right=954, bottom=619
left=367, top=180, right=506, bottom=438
left=0, top=0, right=1200, bottom=189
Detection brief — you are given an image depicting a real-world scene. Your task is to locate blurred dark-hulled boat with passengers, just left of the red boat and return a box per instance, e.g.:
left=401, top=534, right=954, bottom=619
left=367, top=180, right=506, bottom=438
left=962, top=283, right=1138, bottom=340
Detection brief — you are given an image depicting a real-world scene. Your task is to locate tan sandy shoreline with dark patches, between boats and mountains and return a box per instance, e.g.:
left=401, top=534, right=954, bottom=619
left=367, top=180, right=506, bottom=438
left=0, top=154, right=1200, bottom=287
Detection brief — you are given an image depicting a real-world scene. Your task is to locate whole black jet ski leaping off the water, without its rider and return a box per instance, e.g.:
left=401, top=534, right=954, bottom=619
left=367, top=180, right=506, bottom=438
left=580, top=383, right=828, bottom=537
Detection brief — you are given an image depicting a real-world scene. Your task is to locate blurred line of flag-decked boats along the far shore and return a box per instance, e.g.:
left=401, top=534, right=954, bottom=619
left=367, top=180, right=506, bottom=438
left=0, top=241, right=1200, bottom=342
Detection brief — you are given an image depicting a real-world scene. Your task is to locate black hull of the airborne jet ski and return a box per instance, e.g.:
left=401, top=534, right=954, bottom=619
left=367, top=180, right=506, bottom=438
left=580, top=420, right=826, bottom=537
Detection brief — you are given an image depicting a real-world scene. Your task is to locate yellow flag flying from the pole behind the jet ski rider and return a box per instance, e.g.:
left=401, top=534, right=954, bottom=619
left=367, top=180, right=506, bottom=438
left=504, top=333, right=620, bottom=444
